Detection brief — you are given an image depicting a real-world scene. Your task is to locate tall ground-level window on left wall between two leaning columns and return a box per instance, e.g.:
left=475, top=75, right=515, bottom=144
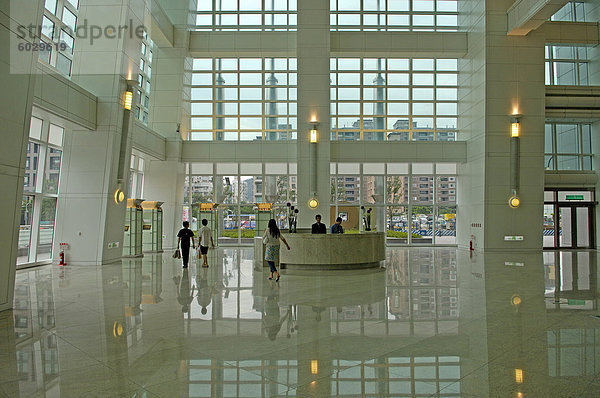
left=17, top=117, right=64, bottom=265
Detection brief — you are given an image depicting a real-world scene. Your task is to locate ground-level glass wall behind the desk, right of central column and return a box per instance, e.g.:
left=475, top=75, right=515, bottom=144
left=329, top=163, right=457, bottom=245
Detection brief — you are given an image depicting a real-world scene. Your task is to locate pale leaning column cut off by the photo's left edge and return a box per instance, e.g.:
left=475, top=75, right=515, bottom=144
left=0, top=1, right=43, bottom=311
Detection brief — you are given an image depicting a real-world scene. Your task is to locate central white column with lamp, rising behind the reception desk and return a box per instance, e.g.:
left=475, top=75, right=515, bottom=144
left=297, top=0, right=331, bottom=228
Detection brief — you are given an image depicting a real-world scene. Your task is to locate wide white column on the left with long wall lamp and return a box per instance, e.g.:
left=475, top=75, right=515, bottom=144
left=55, top=0, right=149, bottom=265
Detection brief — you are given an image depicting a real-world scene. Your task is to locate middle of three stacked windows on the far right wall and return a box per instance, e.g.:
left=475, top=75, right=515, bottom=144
left=546, top=46, right=590, bottom=86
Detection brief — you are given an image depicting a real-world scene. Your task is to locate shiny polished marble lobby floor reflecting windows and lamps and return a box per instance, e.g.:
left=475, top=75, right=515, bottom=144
left=0, top=247, right=600, bottom=397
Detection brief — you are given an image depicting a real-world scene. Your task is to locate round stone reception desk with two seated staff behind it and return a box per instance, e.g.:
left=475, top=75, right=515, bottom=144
left=279, top=232, right=385, bottom=269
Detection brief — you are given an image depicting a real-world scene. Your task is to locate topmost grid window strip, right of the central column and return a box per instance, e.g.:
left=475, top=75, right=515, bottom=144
left=330, top=0, right=458, bottom=31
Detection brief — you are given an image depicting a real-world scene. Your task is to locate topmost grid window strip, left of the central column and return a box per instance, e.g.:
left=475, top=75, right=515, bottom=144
left=196, top=0, right=297, bottom=31
